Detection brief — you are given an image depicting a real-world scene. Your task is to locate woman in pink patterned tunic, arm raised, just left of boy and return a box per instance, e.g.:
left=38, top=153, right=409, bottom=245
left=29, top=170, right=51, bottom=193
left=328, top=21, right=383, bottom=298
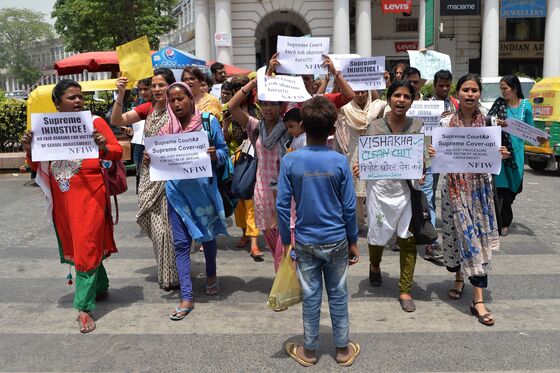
left=228, top=79, right=290, bottom=271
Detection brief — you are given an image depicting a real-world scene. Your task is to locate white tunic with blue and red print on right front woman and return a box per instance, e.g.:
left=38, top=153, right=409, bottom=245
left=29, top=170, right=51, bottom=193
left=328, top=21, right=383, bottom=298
left=442, top=110, right=500, bottom=277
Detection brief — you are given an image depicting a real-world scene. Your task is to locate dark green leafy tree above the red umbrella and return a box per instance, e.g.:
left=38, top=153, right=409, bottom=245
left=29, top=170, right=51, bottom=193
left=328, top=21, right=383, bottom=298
left=52, top=0, right=177, bottom=52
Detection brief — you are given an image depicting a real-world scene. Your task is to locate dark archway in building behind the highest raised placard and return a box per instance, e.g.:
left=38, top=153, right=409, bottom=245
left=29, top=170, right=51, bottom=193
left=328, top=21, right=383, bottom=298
left=255, top=10, right=311, bottom=68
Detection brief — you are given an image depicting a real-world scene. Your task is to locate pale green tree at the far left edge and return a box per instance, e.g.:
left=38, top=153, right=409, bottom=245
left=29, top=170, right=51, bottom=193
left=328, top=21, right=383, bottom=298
left=0, top=8, right=53, bottom=84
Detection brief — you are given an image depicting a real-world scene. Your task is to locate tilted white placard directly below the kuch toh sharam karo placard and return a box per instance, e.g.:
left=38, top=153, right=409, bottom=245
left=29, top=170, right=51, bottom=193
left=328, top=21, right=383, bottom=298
left=257, top=66, right=311, bottom=102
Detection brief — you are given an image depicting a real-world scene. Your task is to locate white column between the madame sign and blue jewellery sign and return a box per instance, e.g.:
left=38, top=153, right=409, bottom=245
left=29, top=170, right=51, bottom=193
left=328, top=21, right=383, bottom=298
left=480, top=0, right=500, bottom=76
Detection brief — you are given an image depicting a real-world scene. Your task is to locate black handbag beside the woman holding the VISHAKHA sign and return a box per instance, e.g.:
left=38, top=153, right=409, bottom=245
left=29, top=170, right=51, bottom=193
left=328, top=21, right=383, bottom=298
left=406, top=180, right=438, bottom=245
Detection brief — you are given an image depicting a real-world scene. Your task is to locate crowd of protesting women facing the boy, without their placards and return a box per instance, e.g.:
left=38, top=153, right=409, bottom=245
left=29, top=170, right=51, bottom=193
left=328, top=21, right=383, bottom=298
left=22, top=56, right=532, bottom=333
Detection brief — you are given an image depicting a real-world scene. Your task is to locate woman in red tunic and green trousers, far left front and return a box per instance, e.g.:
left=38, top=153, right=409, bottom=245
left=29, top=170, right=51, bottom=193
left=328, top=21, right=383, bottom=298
left=21, top=79, right=122, bottom=333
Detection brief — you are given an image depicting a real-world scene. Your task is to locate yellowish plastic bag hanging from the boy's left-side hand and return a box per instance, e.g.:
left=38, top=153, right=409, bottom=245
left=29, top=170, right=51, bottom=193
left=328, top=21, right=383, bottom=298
left=267, top=251, right=301, bottom=309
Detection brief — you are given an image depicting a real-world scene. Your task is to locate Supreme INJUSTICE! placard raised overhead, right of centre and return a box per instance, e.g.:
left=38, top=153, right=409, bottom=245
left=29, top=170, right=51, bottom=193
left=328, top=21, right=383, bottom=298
left=340, top=56, right=385, bottom=91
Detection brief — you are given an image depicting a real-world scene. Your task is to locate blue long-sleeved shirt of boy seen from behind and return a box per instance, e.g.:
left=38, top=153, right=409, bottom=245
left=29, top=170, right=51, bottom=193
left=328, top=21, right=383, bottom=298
left=276, top=146, right=358, bottom=245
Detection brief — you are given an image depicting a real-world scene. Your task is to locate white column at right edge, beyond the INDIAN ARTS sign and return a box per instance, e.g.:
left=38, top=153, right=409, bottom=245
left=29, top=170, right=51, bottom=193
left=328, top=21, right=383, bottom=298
left=543, top=0, right=560, bottom=78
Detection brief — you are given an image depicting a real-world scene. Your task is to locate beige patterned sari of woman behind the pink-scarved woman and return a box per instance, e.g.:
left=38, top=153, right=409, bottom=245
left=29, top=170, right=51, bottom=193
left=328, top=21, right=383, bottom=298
left=136, top=110, right=179, bottom=288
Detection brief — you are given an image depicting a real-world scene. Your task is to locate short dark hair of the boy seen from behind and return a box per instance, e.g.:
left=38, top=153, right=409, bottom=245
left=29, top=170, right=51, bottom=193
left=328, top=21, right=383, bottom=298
left=301, top=96, right=337, bottom=138
